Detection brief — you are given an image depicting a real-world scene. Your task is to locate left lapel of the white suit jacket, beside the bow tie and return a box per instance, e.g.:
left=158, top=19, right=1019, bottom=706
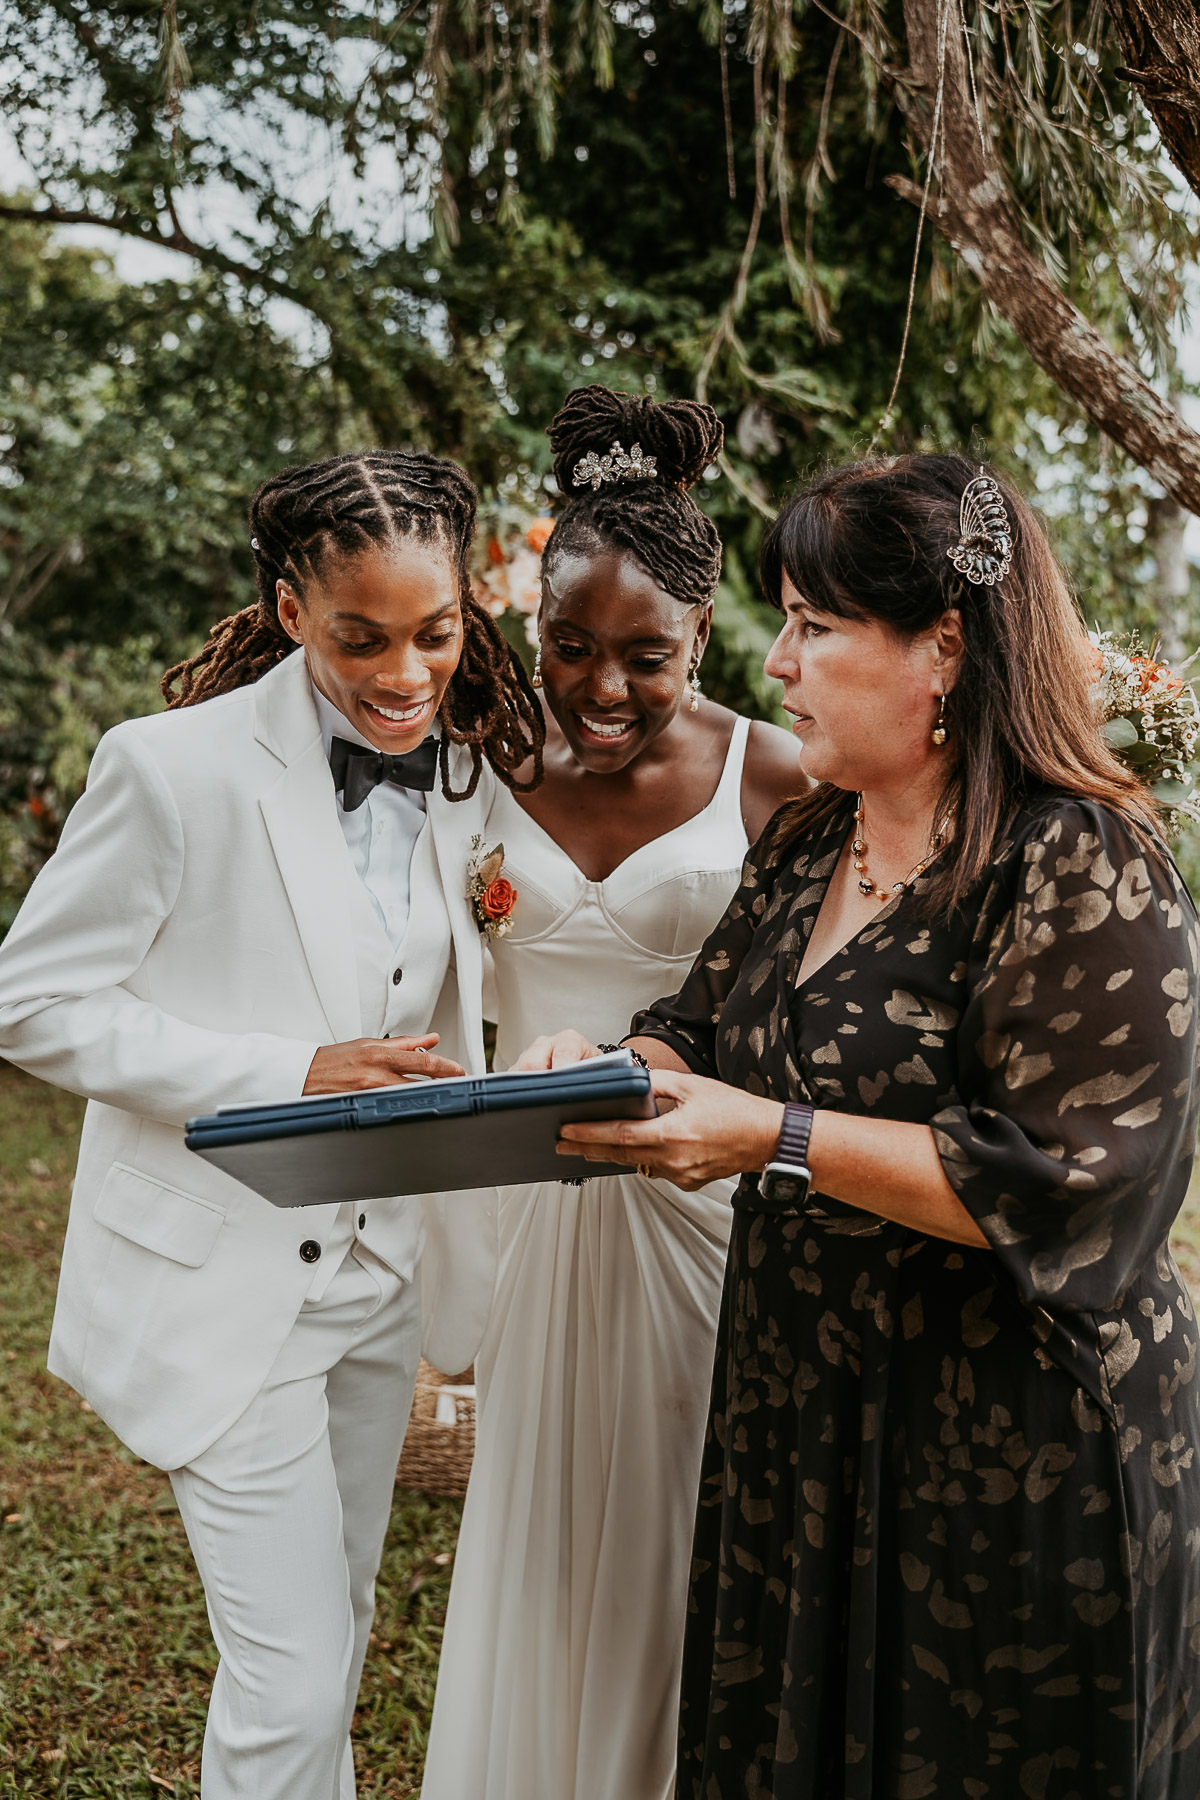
left=255, top=652, right=362, bottom=1042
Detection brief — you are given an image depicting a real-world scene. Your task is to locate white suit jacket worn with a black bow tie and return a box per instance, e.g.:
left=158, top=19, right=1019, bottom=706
left=0, top=652, right=497, bottom=1469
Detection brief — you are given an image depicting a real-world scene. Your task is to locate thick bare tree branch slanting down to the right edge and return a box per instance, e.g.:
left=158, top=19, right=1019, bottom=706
left=889, top=0, right=1200, bottom=513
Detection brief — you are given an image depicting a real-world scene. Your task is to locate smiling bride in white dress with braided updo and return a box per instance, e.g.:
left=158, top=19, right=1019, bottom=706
left=421, top=387, right=802, bottom=1800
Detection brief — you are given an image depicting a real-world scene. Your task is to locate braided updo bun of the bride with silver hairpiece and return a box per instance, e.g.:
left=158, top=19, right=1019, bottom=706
left=543, top=387, right=725, bottom=607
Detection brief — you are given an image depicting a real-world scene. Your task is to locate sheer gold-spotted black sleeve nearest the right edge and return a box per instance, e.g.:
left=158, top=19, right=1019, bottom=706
left=932, top=801, right=1198, bottom=1310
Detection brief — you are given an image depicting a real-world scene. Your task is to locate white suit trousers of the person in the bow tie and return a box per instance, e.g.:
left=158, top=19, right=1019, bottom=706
left=171, top=1244, right=421, bottom=1800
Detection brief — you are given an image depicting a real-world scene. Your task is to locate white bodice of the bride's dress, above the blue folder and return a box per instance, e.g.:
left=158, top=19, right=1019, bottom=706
left=488, top=718, right=750, bottom=1067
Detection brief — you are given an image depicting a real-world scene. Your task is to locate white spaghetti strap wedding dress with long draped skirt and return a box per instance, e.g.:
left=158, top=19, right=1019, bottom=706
left=421, top=720, right=748, bottom=1800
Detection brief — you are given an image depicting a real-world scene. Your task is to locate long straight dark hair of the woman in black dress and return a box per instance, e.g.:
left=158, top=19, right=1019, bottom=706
left=759, top=455, right=1162, bottom=900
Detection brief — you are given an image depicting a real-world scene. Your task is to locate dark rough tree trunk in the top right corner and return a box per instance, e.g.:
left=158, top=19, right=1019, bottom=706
left=1106, top=0, right=1200, bottom=194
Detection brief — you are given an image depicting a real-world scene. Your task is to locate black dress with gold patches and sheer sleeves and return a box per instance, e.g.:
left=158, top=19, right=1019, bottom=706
left=635, top=796, right=1200, bottom=1800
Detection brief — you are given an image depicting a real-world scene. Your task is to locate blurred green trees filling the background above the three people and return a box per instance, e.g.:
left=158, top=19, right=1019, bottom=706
left=0, top=0, right=1200, bottom=931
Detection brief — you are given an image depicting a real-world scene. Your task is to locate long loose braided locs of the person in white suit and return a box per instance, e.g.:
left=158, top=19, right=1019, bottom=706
left=162, top=450, right=545, bottom=799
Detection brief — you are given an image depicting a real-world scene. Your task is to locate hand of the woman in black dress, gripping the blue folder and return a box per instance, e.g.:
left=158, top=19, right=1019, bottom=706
left=558, top=1069, right=783, bottom=1190
